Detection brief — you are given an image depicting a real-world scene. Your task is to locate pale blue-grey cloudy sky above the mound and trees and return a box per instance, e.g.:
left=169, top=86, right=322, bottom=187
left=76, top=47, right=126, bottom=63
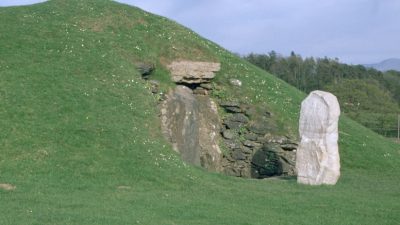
left=0, top=0, right=400, bottom=64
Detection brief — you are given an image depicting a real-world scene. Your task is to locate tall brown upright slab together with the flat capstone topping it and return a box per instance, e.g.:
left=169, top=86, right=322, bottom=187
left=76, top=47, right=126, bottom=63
left=161, top=61, right=222, bottom=171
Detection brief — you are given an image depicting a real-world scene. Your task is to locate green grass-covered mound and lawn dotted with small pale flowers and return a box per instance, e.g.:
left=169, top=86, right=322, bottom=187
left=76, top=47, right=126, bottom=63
left=0, top=0, right=400, bottom=225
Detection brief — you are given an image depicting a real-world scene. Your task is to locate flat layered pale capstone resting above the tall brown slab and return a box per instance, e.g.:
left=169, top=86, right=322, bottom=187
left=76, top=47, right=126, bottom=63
left=167, top=61, right=221, bottom=84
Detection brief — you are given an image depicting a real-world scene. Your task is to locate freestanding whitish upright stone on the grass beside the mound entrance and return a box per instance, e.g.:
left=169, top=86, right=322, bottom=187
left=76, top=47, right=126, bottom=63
left=296, top=91, right=340, bottom=185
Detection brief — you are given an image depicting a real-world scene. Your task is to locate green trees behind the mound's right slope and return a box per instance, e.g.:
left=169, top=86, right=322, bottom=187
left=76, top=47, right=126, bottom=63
left=243, top=51, right=400, bottom=136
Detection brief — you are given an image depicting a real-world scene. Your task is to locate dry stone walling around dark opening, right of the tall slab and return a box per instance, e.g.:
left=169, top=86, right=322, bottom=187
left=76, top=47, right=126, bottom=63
left=219, top=101, right=297, bottom=178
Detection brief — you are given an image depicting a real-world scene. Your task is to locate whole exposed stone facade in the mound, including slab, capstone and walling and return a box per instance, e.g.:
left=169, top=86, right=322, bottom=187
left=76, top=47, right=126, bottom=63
left=137, top=61, right=297, bottom=178
